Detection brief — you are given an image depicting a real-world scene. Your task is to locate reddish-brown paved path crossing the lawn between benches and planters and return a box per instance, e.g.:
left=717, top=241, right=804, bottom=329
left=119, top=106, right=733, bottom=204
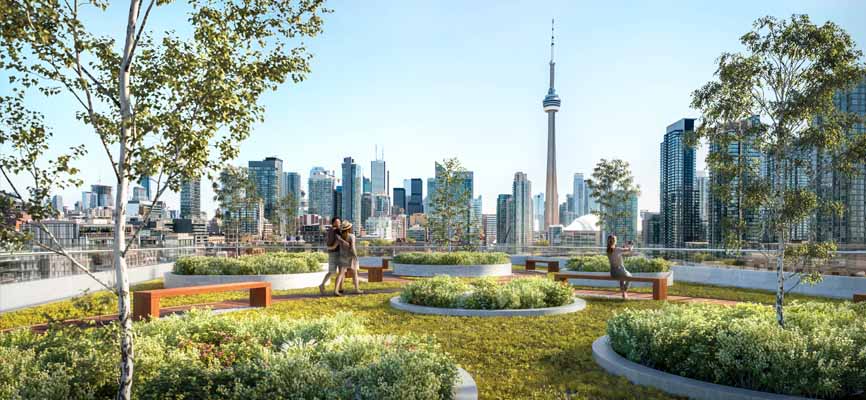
left=13, top=270, right=738, bottom=332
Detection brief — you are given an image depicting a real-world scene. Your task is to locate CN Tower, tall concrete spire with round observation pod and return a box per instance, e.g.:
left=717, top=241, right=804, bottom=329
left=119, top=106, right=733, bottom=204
left=542, top=20, right=560, bottom=231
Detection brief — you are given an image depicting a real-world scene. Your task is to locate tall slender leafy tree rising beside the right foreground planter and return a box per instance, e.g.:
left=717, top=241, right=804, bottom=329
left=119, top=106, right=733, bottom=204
left=692, top=15, right=866, bottom=326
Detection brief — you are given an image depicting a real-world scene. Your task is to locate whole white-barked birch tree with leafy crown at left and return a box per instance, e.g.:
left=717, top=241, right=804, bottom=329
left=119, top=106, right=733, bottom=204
left=0, top=0, right=327, bottom=399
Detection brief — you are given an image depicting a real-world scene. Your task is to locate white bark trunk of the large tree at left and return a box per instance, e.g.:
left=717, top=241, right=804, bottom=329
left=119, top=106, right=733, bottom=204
left=114, top=0, right=141, bottom=400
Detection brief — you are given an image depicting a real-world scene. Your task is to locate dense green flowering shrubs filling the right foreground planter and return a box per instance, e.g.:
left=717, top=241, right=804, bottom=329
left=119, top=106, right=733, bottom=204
left=607, top=302, right=866, bottom=399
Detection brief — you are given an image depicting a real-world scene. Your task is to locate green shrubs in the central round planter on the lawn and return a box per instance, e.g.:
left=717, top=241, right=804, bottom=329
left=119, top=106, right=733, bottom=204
left=400, top=276, right=573, bottom=310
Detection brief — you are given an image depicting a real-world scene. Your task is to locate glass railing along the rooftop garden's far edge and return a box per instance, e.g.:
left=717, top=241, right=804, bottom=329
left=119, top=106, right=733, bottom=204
left=0, top=242, right=866, bottom=285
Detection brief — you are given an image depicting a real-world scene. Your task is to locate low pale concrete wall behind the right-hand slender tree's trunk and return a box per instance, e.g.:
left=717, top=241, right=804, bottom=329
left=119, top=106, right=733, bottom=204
left=671, top=265, right=866, bottom=300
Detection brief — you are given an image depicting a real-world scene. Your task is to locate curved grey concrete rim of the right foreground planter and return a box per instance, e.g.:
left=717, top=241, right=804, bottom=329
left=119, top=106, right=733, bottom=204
left=592, top=336, right=806, bottom=400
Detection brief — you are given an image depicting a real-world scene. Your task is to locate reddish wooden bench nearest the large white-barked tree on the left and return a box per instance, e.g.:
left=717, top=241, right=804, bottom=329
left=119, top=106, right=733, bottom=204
left=132, top=282, right=271, bottom=320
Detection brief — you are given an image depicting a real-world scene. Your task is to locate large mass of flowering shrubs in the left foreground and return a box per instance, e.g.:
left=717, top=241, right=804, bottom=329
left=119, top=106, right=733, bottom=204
left=0, top=311, right=457, bottom=400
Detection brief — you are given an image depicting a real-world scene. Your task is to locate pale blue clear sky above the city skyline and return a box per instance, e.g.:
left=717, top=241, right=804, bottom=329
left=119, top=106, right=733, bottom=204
left=0, top=0, right=866, bottom=219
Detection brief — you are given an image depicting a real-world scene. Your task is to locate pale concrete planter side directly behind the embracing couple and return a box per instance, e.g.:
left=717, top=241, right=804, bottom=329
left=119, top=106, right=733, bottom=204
left=164, top=263, right=328, bottom=290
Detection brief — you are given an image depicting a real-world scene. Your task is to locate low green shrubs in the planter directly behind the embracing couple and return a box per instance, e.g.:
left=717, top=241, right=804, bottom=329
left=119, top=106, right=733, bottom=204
left=174, top=252, right=328, bottom=275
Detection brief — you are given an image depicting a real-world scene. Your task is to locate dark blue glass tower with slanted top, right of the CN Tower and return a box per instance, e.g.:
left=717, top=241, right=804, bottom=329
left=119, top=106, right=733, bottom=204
left=659, top=118, right=701, bottom=247
